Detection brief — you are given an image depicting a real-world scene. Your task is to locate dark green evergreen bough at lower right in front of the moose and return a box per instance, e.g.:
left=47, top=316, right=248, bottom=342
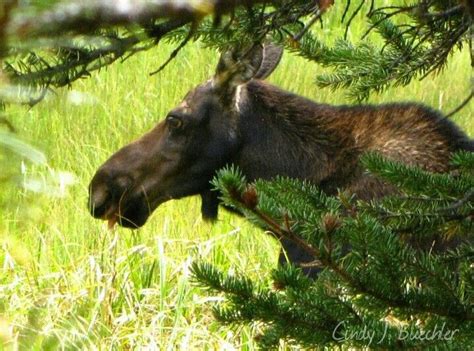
left=193, top=152, right=474, bottom=350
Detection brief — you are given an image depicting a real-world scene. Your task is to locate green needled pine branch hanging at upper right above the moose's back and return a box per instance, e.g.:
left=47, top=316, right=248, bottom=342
left=300, top=0, right=472, bottom=101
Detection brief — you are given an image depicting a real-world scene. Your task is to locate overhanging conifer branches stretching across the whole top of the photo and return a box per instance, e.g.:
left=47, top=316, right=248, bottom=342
left=0, top=0, right=474, bottom=104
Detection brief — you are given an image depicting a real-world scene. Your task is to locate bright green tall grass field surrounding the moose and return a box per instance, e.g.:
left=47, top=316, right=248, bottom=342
left=0, top=4, right=474, bottom=350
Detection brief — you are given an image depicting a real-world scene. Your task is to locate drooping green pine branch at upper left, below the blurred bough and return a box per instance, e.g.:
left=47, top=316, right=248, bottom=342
left=4, top=20, right=193, bottom=106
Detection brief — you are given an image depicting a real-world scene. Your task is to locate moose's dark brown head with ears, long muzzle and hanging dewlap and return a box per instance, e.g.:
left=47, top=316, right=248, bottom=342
left=89, top=44, right=282, bottom=228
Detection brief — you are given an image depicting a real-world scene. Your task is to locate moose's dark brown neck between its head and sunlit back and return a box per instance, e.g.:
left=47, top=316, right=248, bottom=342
left=233, top=81, right=343, bottom=184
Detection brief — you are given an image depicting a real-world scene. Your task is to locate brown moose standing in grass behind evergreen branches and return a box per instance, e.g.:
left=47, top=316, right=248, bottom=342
left=89, top=44, right=474, bottom=274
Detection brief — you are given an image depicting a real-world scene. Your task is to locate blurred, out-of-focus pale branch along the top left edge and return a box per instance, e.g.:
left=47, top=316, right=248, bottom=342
left=11, top=0, right=274, bottom=38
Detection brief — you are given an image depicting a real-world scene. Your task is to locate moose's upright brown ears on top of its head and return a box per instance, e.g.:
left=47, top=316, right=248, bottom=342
left=214, top=44, right=283, bottom=95
